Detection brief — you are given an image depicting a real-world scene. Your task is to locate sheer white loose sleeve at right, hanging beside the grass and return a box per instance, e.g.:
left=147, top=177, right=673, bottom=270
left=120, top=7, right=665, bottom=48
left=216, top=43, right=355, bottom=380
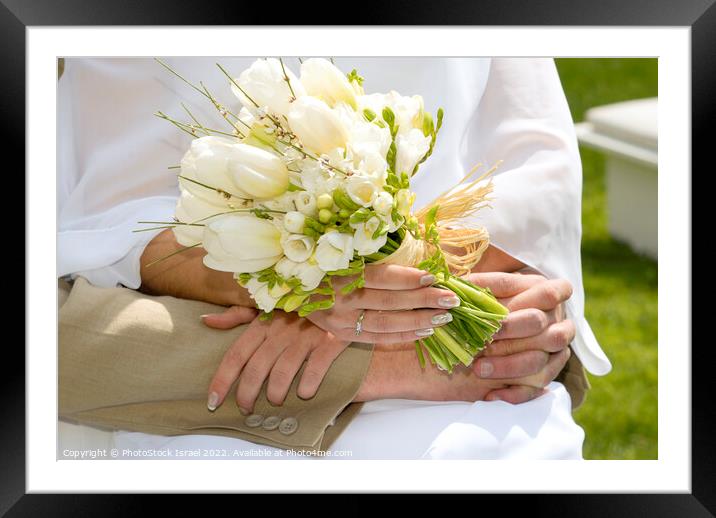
left=461, top=58, right=611, bottom=375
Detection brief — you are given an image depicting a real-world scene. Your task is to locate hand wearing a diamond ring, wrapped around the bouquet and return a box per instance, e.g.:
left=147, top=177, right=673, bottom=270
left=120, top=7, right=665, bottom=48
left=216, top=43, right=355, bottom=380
left=308, top=265, right=460, bottom=344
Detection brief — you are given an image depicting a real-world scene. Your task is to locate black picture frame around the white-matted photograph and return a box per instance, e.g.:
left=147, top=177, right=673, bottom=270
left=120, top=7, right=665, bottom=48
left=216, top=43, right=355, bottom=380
left=8, top=0, right=704, bottom=517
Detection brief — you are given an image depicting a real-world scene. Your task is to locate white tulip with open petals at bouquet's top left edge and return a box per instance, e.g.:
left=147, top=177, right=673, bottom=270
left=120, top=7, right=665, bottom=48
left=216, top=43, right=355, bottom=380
left=231, top=58, right=306, bottom=115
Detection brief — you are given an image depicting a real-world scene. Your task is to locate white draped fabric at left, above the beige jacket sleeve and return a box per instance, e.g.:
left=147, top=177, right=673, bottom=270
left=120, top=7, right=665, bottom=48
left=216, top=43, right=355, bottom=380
left=57, top=58, right=188, bottom=288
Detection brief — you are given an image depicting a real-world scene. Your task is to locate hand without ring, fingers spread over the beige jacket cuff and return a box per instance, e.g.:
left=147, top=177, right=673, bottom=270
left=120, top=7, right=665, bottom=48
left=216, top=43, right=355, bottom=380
left=203, top=306, right=350, bottom=414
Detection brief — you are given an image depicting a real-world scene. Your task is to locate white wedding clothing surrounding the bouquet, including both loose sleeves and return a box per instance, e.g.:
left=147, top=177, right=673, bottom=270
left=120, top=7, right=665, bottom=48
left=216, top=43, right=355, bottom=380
left=57, top=58, right=611, bottom=459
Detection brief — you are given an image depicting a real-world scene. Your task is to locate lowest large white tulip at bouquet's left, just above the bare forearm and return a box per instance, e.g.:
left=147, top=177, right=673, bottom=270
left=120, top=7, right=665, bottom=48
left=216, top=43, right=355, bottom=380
left=204, top=215, right=283, bottom=273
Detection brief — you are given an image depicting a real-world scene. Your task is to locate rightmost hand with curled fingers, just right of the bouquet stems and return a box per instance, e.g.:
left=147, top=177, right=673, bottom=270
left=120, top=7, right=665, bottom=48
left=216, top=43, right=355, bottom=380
left=469, top=272, right=575, bottom=404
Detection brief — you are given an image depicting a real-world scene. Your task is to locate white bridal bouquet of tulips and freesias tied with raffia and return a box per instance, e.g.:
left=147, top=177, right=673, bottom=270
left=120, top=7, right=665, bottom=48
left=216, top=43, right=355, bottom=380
left=141, top=58, right=507, bottom=371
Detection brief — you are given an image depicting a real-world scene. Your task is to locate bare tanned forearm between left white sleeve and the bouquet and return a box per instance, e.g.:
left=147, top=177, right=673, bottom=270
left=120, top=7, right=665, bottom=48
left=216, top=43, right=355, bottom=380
left=139, top=230, right=255, bottom=307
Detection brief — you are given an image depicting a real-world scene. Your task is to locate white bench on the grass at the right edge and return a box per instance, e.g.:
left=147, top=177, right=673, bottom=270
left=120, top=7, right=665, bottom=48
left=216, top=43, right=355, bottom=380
left=576, top=98, right=658, bottom=259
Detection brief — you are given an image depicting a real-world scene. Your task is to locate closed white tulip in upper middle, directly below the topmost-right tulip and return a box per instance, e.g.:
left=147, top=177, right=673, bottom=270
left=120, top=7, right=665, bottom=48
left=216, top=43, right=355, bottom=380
left=288, top=96, right=348, bottom=154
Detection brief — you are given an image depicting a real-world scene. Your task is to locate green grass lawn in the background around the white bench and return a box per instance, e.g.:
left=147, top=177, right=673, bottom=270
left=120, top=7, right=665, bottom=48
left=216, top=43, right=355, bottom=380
left=556, top=58, right=658, bottom=459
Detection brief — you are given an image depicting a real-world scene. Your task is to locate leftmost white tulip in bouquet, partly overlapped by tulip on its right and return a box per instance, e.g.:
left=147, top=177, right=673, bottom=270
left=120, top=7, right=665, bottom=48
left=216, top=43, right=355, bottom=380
left=179, top=136, right=251, bottom=205
